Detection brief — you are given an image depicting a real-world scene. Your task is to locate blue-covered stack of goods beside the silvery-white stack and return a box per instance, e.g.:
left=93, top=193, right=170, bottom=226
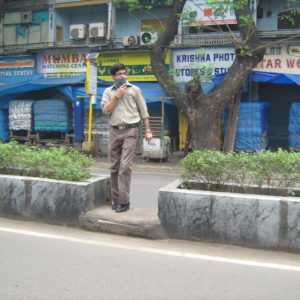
left=33, top=99, right=72, bottom=132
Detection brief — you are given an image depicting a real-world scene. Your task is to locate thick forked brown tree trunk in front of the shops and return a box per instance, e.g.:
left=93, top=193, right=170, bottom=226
left=151, top=0, right=265, bottom=150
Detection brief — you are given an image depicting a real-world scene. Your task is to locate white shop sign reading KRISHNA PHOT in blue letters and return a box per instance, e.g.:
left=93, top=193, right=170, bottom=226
left=172, top=47, right=235, bottom=82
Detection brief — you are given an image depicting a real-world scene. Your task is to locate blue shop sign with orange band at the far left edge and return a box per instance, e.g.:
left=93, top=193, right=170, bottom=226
left=0, top=56, right=36, bottom=83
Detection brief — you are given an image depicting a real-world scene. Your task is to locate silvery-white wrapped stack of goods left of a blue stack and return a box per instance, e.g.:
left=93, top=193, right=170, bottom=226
left=9, top=100, right=33, bottom=131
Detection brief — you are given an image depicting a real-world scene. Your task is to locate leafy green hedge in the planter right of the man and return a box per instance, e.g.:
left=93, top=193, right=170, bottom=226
left=182, top=149, right=300, bottom=192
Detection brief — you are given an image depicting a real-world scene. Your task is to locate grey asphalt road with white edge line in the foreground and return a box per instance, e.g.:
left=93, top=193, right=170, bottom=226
left=0, top=218, right=300, bottom=300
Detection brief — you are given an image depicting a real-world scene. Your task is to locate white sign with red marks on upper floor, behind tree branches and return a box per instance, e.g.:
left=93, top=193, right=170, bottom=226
left=184, top=0, right=237, bottom=26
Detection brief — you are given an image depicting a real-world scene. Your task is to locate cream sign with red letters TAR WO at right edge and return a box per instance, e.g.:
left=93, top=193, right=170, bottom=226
left=254, top=45, right=300, bottom=74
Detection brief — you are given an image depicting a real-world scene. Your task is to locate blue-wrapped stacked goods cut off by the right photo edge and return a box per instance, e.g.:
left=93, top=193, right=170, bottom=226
left=289, top=102, right=300, bottom=149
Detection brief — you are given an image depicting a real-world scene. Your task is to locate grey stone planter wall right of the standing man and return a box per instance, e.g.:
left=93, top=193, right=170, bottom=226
left=158, top=180, right=300, bottom=252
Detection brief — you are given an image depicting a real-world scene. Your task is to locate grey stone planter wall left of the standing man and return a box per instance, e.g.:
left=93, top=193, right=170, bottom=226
left=0, top=175, right=110, bottom=225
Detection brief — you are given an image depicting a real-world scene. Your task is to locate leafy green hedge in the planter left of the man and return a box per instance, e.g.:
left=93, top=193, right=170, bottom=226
left=0, top=142, right=93, bottom=181
